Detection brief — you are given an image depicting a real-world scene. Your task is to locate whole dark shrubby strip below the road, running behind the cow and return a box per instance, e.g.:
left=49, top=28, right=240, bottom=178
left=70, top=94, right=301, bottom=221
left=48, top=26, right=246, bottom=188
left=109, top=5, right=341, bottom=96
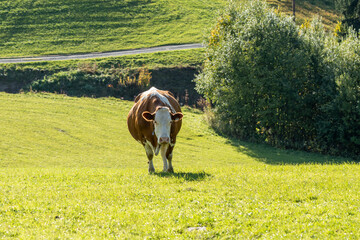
left=0, top=62, right=200, bottom=105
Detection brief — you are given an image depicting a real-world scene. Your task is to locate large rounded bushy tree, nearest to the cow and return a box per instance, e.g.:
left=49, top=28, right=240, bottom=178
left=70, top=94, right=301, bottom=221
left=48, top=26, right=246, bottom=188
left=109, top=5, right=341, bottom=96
left=196, top=1, right=334, bottom=148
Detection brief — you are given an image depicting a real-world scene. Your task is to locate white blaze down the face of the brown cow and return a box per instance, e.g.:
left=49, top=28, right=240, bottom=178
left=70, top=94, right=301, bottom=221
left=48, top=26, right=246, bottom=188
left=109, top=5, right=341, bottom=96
left=154, top=108, right=172, bottom=143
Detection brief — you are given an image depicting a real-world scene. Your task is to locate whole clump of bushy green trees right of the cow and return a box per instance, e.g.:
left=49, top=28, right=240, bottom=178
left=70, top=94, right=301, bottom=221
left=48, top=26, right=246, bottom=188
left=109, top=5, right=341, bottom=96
left=196, top=1, right=360, bottom=158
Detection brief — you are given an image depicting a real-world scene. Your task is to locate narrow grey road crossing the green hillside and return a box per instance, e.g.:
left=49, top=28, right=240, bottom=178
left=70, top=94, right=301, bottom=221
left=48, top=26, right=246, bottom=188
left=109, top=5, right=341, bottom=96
left=0, top=43, right=203, bottom=63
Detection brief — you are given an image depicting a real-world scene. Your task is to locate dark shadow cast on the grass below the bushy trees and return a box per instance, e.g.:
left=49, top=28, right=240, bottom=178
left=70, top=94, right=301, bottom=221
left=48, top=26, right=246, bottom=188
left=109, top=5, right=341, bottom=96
left=227, top=139, right=357, bottom=165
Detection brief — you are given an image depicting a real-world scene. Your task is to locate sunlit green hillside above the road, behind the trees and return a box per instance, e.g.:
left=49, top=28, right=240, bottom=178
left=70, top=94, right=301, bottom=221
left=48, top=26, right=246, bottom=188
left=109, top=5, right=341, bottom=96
left=0, top=0, right=339, bottom=57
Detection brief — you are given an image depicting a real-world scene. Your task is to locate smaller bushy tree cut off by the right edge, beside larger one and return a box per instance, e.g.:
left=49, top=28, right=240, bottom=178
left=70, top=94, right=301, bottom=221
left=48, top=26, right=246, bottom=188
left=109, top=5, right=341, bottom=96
left=318, top=29, right=360, bottom=158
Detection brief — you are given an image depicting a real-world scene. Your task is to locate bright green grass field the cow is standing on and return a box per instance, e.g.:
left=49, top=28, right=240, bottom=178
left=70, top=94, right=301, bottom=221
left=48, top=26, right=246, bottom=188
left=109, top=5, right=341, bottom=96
left=0, top=93, right=360, bottom=239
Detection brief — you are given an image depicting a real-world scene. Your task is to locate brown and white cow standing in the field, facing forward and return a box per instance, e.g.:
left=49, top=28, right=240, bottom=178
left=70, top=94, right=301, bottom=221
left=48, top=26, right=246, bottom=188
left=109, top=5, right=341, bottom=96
left=127, top=87, right=183, bottom=172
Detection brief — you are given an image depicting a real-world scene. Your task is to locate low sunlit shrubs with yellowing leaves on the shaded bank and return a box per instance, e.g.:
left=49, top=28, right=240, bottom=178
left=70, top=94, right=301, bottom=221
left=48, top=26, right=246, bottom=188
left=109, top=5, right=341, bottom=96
left=29, top=65, right=151, bottom=99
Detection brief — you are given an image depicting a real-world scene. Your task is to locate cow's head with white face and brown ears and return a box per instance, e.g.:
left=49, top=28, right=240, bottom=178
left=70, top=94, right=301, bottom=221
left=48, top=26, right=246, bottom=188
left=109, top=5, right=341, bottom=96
left=142, top=107, right=183, bottom=144
